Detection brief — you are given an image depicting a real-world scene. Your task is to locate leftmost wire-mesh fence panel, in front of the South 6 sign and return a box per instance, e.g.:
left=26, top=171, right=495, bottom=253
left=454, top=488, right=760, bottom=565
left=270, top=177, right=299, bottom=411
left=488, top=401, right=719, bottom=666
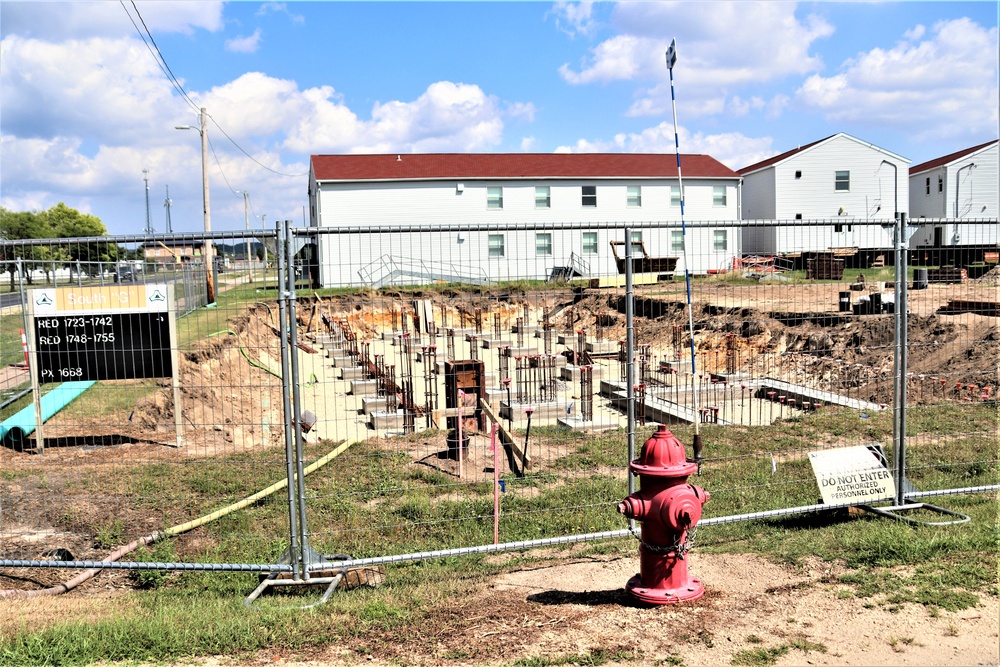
left=0, top=239, right=288, bottom=576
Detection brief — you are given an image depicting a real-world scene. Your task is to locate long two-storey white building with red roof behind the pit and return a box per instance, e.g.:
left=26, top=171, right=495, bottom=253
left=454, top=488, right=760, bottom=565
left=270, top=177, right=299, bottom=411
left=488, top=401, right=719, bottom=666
left=309, top=153, right=741, bottom=287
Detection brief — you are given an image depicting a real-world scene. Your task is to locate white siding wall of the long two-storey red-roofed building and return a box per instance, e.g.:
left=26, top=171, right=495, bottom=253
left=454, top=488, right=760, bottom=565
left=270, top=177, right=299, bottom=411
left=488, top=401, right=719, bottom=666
left=314, top=178, right=740, bottom=286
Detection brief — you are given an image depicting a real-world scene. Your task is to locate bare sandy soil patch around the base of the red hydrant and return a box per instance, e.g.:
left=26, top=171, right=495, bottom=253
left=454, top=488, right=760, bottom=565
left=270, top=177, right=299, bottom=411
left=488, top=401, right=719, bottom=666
left=286, top=554, right=1000, bottom=667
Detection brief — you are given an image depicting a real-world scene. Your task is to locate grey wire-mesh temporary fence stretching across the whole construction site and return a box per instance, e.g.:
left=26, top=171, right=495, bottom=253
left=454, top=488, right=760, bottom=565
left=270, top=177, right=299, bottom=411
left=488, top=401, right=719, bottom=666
left=0, top=219, right=1000, bottom=584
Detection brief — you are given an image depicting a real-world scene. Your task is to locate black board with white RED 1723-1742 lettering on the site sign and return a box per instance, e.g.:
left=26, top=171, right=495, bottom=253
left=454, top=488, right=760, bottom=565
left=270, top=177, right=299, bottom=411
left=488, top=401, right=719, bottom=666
left=35, top=312, right=173, bottom=383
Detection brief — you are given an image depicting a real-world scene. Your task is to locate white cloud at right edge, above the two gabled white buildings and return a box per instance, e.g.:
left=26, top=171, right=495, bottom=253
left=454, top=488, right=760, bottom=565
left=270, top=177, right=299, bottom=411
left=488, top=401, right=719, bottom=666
left=796, top=18, right=1000, bottom=141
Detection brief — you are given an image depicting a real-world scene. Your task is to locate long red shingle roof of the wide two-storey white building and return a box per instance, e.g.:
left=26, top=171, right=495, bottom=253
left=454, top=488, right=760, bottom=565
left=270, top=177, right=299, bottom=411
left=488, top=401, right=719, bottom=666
left=311, top=153, right=739, bottom=181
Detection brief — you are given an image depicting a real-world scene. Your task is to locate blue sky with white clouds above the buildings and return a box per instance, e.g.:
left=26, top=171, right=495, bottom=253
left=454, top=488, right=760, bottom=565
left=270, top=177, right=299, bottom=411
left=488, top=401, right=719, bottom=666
left=0, top=0, right=1000, bottom=234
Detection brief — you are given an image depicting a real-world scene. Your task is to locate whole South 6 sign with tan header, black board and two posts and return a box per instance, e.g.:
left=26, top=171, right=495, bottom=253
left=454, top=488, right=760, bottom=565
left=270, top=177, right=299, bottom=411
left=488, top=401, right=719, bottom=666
left=28, top=284, right=181, bottom=453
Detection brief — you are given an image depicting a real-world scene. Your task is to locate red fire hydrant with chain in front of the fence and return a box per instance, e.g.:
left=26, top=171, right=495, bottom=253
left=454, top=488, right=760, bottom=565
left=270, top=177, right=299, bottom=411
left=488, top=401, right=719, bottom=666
left=618, top=425, right=709, bottom=605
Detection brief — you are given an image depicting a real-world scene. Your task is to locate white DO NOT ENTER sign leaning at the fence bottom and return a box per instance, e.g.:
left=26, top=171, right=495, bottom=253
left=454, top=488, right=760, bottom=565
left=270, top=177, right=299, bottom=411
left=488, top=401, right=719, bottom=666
left=809, top=445, right=895, bottom=505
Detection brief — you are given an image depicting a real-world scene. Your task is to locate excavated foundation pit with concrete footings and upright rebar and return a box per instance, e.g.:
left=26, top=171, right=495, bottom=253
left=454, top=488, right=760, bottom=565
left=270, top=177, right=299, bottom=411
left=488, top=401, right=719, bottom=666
left=286, top=271, right=997, bottom=480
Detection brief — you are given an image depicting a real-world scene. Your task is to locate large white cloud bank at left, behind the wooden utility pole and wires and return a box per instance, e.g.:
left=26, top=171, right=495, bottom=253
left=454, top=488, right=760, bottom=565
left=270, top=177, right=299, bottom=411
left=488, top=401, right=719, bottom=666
left=0, top=23, right=535, bottom=233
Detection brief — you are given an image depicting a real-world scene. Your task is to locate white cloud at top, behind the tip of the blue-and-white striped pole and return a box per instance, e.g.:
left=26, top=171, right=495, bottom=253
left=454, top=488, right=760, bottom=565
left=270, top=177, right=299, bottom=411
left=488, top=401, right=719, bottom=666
left=559, top=2, right=834, bottom=116
